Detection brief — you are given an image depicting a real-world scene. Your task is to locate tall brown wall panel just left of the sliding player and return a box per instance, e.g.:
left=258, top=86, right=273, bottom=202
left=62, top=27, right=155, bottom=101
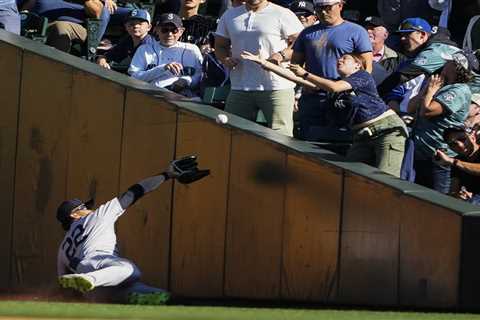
left=13, top=52, right=72, bottom=287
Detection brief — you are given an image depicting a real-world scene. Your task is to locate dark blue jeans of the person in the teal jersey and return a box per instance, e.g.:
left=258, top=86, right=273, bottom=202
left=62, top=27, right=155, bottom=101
left=413, top=160, right=452, bottom=194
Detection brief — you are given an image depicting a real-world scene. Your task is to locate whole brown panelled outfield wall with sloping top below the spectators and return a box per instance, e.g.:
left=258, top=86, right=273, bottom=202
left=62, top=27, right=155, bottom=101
left=0, top=30, right=480, bottom=308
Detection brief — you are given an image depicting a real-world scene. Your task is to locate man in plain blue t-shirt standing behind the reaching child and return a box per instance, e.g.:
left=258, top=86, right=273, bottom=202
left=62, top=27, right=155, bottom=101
left=292, top=0, right=372, bottom=140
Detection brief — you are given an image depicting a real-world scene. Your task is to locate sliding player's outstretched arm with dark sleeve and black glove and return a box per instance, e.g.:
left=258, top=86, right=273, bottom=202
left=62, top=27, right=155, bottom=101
left=118, top=156, right=210, bottom=209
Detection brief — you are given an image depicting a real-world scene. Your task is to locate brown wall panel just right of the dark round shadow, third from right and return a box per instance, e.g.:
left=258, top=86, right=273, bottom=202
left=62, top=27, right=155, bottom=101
left=282, top=154, right=343, bottom=302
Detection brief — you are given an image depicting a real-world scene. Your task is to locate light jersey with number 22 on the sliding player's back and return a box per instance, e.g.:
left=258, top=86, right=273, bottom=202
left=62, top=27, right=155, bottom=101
left=57, top=198, right=125, bottom=275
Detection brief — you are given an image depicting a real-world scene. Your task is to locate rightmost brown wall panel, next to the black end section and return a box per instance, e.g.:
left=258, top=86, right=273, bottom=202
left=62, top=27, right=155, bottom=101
left=399, top=197, right=462, bottom=308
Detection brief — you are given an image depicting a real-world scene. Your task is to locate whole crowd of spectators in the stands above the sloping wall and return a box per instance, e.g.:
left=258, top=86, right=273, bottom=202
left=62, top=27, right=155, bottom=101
left=0, top=0, right=480, bottom=204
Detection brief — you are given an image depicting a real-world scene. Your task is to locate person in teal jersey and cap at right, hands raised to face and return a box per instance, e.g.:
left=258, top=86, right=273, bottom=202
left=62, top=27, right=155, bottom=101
left=408, top=51, right=478, bottom=194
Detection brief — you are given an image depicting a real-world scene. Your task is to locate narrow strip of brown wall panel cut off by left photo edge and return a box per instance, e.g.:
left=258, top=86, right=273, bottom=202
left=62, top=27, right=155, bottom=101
left=0, top=42, right=22, bottom=291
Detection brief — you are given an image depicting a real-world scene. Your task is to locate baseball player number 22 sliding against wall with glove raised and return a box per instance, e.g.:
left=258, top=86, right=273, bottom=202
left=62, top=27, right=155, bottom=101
left=57, top=156, right=210, bottom=304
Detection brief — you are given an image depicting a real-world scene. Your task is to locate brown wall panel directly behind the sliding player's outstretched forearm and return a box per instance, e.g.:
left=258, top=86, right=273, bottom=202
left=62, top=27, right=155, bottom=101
left=118, top=90, right=176, bottom=288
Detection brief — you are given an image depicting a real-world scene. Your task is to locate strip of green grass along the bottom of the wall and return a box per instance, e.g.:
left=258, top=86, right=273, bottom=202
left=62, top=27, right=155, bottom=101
left=0, top=301, right=480, bottom=320
